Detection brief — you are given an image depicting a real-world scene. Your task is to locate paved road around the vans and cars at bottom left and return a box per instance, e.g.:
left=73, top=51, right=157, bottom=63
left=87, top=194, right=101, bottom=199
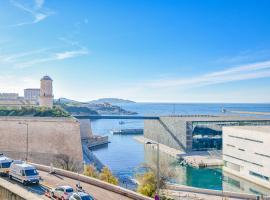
left=1, top=170, right=132, bottom=200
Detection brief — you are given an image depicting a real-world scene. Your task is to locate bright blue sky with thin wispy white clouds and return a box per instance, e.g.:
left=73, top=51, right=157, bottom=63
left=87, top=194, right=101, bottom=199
left=0, top=0, right=270, bottom=103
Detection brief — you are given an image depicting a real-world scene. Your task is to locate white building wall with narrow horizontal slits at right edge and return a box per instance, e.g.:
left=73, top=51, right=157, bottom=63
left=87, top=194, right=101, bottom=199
left=223, top=126, right=270, bottom=189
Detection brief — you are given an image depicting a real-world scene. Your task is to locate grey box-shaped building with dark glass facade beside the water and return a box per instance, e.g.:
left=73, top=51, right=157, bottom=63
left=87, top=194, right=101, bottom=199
left=144, top=115, right=270, bottom=152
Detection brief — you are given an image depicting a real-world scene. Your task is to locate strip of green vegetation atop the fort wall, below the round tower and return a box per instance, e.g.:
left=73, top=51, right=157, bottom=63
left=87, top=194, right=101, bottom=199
left=0, top=106, right=70, bottom=117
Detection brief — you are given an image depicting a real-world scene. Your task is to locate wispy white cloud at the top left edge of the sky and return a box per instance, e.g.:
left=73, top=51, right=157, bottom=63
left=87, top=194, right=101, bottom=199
left=10, top=0, right=54, bottom=26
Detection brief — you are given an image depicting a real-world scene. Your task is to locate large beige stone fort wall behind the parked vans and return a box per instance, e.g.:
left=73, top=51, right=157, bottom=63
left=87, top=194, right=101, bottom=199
left=0, top=117, right=82, bottom=164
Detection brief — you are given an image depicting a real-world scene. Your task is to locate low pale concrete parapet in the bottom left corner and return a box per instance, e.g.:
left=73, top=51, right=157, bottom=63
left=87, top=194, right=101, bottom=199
left=0, top=178, right=42, bottom=200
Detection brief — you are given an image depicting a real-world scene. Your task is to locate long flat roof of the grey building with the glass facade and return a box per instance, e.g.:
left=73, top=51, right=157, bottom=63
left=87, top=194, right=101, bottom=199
left=160, top=115, right=270, bottom=121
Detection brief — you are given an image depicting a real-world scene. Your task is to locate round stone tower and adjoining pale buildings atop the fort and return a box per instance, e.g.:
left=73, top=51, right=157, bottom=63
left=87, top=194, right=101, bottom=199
left=0, top=76, right=53, bottom=108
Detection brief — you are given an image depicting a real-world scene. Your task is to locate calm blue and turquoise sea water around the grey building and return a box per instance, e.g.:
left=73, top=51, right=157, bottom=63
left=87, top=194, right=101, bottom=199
left=92, top=103, right=270, bottom=194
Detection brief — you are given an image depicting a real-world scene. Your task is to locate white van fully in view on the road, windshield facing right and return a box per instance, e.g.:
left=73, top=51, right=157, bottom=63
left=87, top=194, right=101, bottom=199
left=9, top=161, right=40, bottom=185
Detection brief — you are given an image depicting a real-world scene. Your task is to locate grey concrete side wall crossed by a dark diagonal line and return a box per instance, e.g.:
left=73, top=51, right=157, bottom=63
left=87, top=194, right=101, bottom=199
left=144, top=117, right=187, bottom=151
